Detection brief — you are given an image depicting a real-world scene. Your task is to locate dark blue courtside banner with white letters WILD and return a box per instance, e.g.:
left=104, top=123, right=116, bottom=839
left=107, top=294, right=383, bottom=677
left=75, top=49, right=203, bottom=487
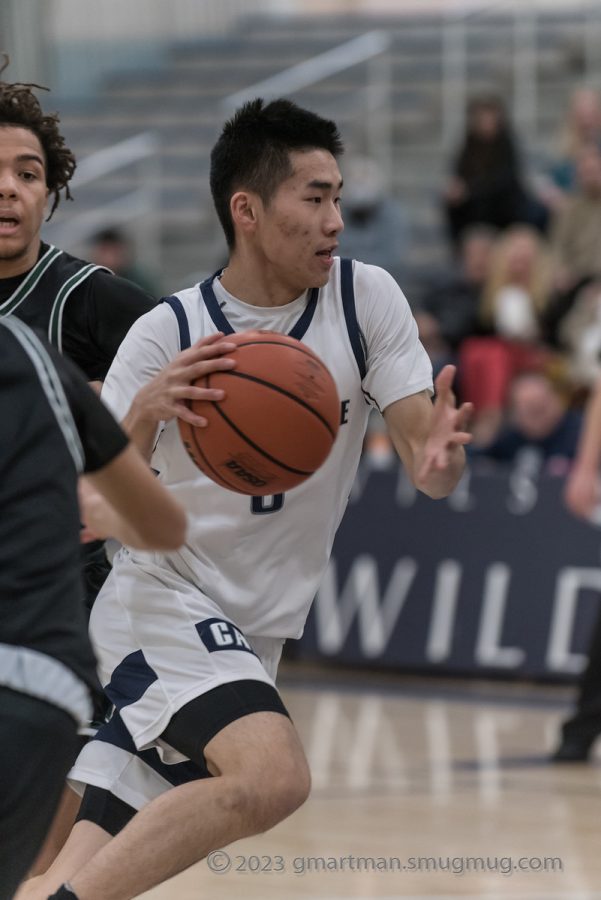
left=293, top=457, right=601, bottom=681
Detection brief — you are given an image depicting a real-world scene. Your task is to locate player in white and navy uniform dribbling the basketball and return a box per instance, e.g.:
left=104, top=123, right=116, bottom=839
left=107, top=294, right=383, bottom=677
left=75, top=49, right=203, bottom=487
left=30, top=100, right=469, bottom=900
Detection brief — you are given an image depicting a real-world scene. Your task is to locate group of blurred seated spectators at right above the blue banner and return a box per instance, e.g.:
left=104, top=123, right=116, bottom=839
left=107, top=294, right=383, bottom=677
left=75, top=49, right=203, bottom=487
left=390, top=86, right=601, bottom=468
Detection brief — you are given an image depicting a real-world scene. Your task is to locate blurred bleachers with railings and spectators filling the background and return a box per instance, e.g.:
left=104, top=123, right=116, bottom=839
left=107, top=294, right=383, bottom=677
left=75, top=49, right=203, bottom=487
left=7, top=0, right=601, bottom=471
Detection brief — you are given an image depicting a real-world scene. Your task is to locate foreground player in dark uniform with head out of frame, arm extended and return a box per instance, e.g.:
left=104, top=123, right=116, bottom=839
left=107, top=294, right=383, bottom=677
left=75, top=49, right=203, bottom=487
left=0, top=316, right=186, bottom=900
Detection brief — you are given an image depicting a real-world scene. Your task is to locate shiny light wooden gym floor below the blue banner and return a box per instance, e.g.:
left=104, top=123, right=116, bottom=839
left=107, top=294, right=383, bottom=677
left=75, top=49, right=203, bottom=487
left=144, top=663, right=601, bottom=900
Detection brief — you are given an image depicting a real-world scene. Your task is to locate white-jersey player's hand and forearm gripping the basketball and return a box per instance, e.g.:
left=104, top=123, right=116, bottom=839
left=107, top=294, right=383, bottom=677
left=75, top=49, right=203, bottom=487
left=122, top=333, right=236, bottom=459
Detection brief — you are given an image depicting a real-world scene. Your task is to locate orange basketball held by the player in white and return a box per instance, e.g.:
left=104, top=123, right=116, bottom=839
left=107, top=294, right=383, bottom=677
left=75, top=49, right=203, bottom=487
left=178, top=331, right=340, bottom=496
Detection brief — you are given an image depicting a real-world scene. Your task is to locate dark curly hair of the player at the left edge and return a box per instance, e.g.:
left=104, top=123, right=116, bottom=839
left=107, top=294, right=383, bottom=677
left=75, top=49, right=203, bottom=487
left=0, top=57, right=77, bottom=219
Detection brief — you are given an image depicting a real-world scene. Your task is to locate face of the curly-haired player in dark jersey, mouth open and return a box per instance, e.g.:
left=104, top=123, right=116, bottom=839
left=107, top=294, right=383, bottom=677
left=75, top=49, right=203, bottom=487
left=0, top=126, right=48, bottom=278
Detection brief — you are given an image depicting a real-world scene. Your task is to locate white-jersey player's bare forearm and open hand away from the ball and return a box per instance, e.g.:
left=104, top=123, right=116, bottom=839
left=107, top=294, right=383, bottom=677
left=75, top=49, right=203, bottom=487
left=384, top=366, right=472, bottom=499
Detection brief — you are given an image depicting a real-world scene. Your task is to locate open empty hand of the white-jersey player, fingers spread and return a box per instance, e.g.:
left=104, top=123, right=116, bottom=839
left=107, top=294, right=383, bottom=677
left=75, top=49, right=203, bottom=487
left=418, top=366, right=473, bottom=481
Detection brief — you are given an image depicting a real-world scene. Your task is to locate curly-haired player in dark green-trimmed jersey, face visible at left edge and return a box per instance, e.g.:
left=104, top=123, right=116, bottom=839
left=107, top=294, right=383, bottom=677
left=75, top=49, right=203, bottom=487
left=0, top=69, right=155, bottom=876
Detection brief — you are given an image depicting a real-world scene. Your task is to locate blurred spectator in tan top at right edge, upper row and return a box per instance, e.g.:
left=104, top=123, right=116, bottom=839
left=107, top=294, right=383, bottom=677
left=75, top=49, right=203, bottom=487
left=551, top=144, right=601, bottom=292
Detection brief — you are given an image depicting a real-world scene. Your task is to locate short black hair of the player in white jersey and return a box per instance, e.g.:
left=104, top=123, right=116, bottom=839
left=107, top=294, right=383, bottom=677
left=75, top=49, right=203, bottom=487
left=210, top=97, right=344, bottom=250
